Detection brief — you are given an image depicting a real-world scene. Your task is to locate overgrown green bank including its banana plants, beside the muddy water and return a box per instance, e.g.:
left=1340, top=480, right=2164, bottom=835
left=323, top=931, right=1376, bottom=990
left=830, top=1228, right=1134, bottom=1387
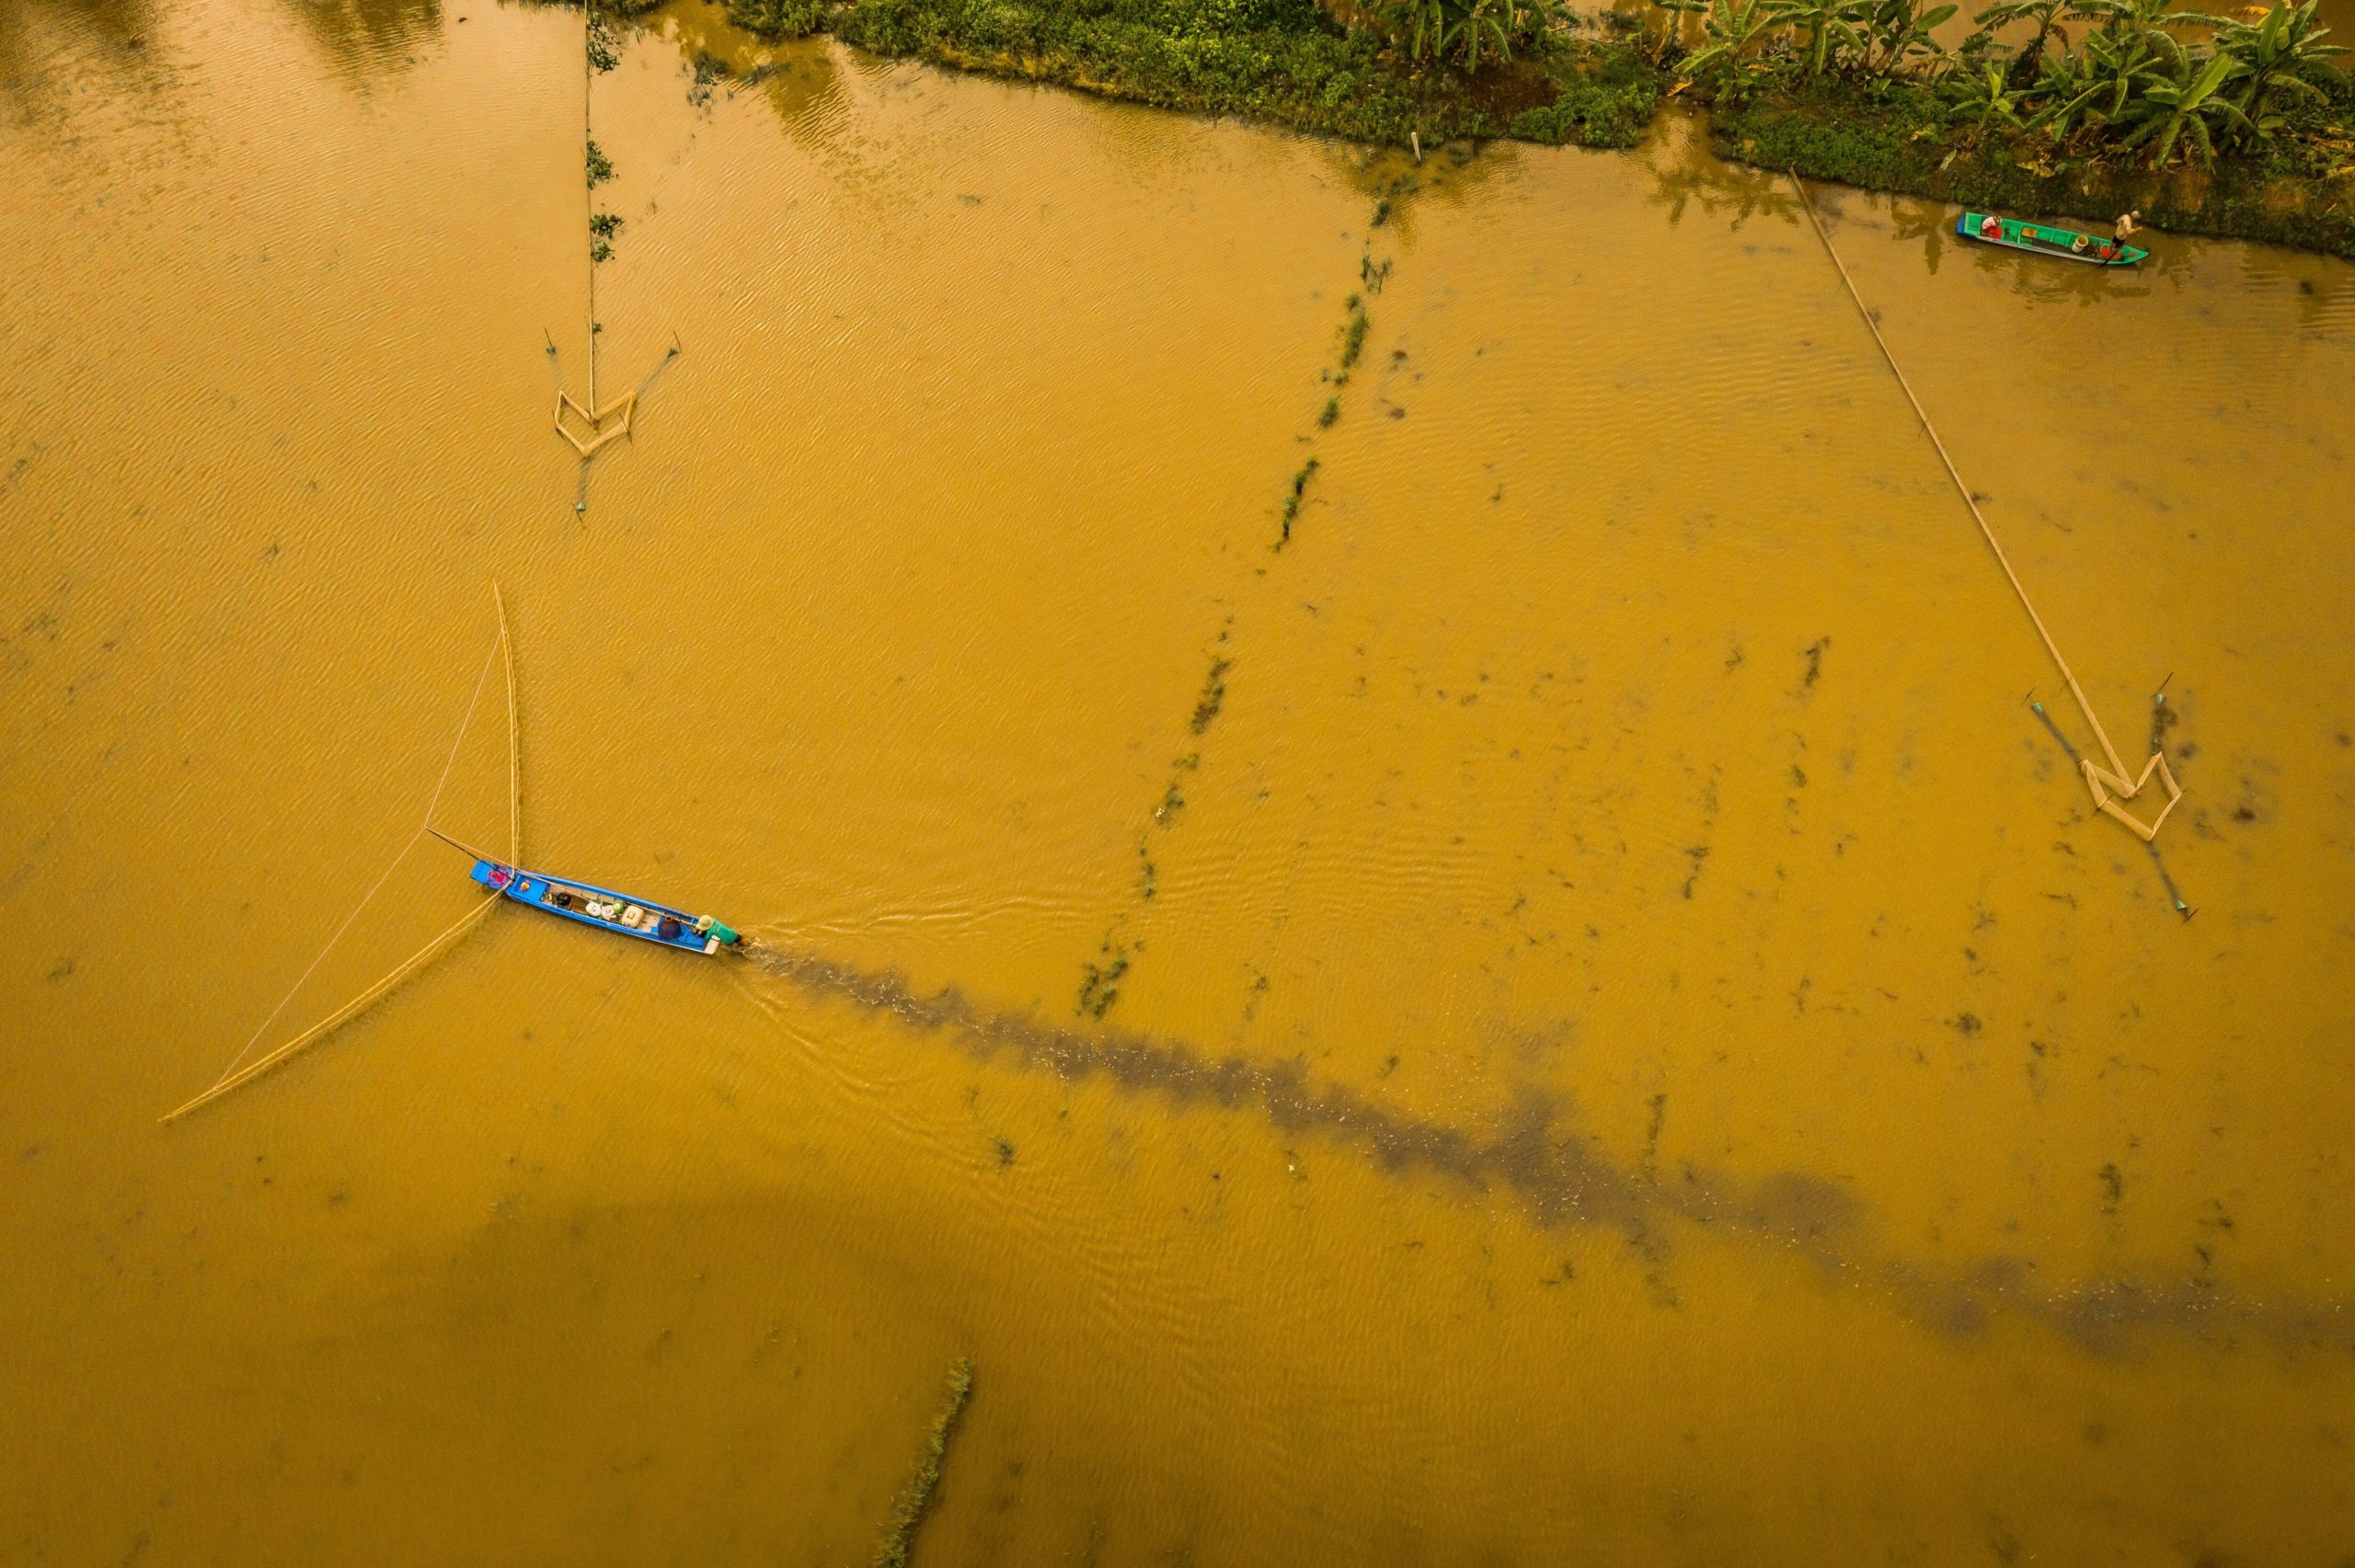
left=701, top=0, right=2355, bottom=259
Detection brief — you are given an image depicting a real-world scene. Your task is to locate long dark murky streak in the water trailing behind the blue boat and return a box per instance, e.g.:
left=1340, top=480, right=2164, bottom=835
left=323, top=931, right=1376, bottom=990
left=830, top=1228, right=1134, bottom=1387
left=749, top=946, right=2355, bottom=1354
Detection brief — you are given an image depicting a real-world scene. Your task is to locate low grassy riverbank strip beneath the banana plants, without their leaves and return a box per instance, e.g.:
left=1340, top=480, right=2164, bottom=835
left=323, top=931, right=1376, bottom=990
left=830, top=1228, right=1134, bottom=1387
left=728, top=0, right=2355, bottom=259
